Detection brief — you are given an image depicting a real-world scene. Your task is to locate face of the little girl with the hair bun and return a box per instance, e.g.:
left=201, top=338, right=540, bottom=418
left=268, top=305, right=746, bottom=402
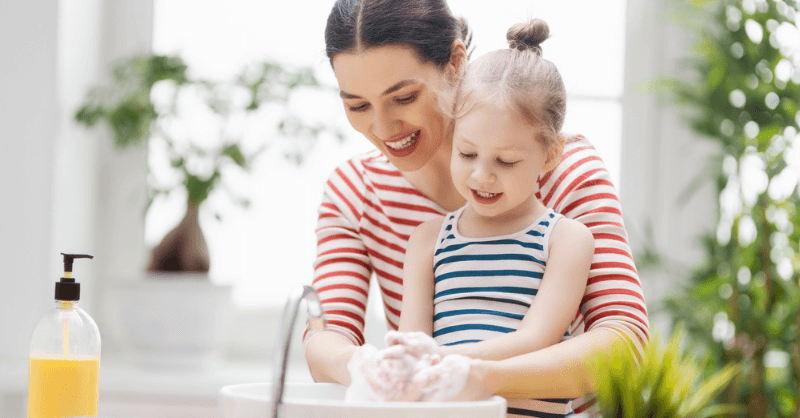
left=450, top=103, right=547, bottom=221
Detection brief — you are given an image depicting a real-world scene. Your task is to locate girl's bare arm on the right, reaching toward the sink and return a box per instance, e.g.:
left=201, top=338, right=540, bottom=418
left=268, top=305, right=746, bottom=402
left=444, top=218, right=594, bottom=360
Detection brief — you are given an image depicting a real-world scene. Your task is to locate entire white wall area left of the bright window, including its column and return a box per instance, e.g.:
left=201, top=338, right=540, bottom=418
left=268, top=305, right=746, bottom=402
left=0, top=0, right=152, bottom=417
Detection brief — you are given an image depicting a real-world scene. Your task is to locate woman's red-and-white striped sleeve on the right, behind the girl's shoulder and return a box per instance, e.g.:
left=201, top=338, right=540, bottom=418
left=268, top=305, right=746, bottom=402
left=539, top=136, right=650, bottom=355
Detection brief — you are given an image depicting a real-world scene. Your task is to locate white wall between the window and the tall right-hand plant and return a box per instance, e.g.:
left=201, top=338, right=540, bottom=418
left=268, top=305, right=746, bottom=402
left=620, top=0, right=716, bottom=329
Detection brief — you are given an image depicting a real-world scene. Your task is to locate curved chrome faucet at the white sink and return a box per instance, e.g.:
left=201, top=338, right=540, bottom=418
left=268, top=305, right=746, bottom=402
left=272, top=286, right=327, bottom=418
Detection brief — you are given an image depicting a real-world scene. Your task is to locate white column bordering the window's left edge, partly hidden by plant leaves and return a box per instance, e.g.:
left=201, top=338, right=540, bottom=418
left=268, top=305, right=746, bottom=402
left=89, top=0, right=153, bottom=350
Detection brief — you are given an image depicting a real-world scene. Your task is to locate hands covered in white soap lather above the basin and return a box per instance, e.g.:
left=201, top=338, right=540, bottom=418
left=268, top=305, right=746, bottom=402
left=345, top=331, right=478, bottom=402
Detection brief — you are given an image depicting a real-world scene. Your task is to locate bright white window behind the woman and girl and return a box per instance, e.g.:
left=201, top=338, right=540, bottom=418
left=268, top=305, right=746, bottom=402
left=145, top=0, right=625, bottom=307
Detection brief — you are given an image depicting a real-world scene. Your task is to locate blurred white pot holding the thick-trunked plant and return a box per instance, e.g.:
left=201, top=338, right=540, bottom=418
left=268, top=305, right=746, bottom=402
left=112, top=273, right=231, bottom=368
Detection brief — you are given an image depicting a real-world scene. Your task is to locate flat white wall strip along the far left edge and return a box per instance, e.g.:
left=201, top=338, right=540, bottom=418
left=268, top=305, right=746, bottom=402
left=0, top=0, right=60, bottom=361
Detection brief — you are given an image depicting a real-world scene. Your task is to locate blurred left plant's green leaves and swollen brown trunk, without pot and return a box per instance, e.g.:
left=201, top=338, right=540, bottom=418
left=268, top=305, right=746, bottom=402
left=75, top=55, right=341, bottom=272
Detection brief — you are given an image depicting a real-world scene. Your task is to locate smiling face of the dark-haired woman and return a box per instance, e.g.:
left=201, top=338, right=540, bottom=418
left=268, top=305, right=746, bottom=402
left=333, top=45, right=450, bottom=171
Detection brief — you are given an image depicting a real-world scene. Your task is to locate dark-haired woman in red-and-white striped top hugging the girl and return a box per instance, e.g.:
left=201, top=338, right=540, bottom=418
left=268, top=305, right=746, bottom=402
left=305, top=0, right=649, bottom=412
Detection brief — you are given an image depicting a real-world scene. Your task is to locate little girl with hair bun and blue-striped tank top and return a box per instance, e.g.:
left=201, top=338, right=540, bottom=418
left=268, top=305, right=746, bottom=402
left=399, top=19, right=594, bottom=417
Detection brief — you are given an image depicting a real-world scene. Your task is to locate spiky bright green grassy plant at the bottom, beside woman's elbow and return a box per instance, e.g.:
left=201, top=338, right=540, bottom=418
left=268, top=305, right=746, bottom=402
left=592, top=329, right=742, bottom=418
